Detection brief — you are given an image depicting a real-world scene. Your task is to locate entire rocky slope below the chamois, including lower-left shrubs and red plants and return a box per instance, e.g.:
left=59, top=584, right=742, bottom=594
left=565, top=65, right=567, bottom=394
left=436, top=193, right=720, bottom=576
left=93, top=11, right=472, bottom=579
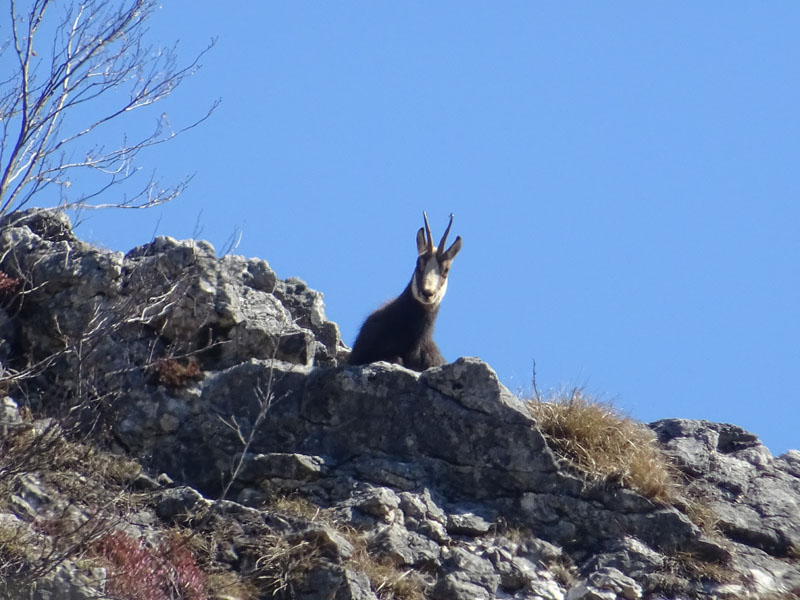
left=0, top=211, right=800, bottom=600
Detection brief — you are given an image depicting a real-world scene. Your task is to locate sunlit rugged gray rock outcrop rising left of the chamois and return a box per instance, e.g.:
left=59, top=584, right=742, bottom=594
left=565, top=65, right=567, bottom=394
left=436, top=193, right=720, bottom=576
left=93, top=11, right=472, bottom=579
left=0, top=211, right=343, bottom=380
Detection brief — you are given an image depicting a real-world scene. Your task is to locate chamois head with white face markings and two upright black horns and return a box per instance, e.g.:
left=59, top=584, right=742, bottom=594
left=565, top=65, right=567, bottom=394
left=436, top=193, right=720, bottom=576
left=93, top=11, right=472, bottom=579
left=411, top=211, right=461, bottom=308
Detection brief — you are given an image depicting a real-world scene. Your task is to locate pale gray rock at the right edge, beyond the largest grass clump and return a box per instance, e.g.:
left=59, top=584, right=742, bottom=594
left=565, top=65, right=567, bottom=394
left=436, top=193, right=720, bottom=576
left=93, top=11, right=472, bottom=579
left=651, top=419, right=800, bottom=592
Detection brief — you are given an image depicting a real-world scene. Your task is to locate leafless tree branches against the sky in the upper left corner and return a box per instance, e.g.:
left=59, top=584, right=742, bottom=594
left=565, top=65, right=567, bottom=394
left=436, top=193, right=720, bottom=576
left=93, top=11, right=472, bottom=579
left=0, top=0, right=219, bottom=217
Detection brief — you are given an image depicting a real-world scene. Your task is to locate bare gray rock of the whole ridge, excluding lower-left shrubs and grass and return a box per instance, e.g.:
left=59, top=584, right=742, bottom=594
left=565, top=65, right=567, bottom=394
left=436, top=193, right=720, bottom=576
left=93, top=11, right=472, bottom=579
left=0, top=212, right=800, bottom=600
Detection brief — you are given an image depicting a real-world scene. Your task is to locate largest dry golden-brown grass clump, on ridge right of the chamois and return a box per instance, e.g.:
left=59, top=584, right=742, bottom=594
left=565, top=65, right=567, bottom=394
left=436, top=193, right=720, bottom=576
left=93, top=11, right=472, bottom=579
left=528, top=389, right=678, bottom=504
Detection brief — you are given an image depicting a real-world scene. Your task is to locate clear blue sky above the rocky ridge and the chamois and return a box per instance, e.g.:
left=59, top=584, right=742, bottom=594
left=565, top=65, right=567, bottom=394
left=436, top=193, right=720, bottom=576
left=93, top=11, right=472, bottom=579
left=70, top=1, right=800, bottom=454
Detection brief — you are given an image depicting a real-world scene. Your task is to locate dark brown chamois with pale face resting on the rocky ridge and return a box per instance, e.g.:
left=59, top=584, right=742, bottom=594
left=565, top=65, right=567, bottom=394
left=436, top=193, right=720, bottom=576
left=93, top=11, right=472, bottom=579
left=348, top=212, right=461, bottom=371
